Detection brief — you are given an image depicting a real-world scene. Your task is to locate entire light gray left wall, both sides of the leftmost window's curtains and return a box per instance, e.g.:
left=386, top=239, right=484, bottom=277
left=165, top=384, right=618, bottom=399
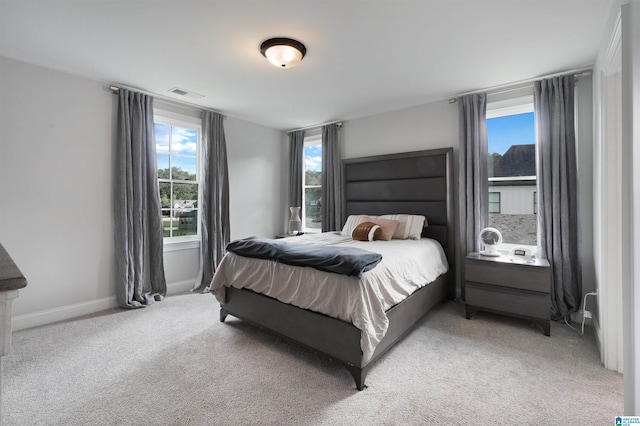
left=0, top=57, right=282, bottom=329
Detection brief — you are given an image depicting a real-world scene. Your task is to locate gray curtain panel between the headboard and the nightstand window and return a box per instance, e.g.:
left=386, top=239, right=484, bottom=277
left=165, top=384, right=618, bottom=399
left=458, top=93, right=489, bottom=260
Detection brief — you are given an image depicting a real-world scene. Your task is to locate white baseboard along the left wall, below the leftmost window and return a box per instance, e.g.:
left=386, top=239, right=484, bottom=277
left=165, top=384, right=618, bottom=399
left=11, top=280, right=195, bottom=331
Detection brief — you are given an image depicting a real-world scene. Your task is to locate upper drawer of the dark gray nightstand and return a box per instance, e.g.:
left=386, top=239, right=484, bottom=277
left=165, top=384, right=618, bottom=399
left=465, top=260, right=551, bottom=293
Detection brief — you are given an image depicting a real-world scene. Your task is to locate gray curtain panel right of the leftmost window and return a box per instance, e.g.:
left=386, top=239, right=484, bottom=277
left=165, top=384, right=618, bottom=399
left=193, top=110, right=231, bottom=293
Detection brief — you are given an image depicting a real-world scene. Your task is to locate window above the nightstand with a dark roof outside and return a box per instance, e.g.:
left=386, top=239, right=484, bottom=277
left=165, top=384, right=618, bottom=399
left=487, top=96, right=538, bottom=252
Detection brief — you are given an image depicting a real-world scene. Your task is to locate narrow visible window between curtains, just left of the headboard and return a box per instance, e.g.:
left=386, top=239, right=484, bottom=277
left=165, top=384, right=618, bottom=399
left=302, top=134, right=322, bottom=232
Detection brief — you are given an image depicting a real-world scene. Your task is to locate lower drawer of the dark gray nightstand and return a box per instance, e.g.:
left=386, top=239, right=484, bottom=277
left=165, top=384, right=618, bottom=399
left=465, top=281, right=551, bottom=319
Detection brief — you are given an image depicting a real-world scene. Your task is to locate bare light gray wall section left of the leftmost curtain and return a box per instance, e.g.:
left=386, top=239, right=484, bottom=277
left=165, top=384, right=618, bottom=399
left=0, top=58, right=114, bottom=326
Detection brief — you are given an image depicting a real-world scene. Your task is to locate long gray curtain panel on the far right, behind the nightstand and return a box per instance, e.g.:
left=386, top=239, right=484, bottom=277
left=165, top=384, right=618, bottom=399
left=533, top=75, right=582, bottom=320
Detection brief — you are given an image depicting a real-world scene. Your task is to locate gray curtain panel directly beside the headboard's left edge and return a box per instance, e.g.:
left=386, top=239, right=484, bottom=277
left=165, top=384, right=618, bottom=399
left=321, top=123, right=343, bottom=232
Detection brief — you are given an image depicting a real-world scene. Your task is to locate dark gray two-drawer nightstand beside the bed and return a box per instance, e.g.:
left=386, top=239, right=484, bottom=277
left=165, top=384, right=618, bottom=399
left=464, top=253, right=551, bottom=336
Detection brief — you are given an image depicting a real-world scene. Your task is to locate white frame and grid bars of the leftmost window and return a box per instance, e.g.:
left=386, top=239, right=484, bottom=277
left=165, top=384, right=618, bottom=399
left=153, top=108, right=202, bottom=245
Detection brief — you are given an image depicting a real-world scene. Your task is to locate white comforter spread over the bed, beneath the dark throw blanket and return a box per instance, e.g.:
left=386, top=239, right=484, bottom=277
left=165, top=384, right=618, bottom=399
left=211, top=232, right=448, bottom=361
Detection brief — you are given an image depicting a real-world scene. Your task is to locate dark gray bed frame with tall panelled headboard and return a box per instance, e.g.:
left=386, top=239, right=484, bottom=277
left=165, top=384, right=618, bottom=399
left=211, top=148, right=455, bottom=390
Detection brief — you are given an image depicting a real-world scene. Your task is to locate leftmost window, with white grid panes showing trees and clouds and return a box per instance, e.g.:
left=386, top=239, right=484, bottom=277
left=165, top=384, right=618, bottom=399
left=154, top=115, right=200, bottom=241
